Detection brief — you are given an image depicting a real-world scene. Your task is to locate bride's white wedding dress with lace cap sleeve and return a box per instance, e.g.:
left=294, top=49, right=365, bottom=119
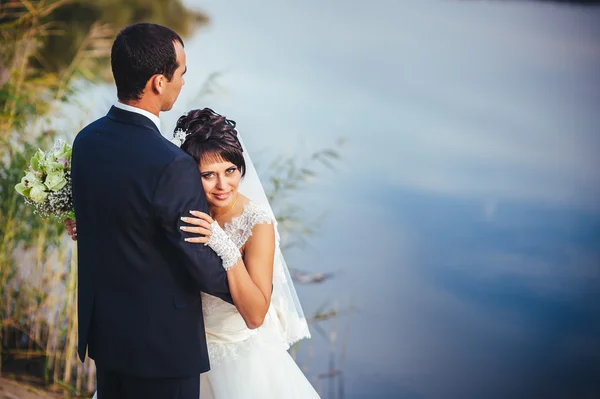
left=200, top=202, right=319, bottom=399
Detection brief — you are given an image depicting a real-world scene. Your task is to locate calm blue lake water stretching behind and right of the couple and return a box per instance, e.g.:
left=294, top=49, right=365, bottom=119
left=76, top=0, right=600, bottom=399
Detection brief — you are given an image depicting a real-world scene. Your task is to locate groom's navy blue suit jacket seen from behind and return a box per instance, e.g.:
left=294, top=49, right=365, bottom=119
left=72, top=107, right=232, bottom=378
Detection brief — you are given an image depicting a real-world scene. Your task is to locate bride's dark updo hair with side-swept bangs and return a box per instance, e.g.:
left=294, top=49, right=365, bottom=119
left=175, top=108, right=246, bottom=177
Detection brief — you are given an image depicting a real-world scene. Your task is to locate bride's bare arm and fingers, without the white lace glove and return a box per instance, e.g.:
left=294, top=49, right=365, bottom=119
left=184, top=212, right=275, bottom=329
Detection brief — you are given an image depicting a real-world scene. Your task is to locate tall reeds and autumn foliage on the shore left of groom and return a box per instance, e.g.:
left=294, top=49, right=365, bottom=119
left=0, top=0, right=208, bottom=397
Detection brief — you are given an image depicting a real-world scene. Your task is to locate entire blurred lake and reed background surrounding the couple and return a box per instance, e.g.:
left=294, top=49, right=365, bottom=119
left=0, top=0, right=600, bottom=399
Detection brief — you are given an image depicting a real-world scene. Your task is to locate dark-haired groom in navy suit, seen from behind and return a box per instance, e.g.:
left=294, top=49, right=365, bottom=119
left=72, top=23, right=232, bottom=399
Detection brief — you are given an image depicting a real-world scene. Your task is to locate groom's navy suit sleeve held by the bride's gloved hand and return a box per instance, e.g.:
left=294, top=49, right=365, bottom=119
left=154, top=155, right=233, bottom=303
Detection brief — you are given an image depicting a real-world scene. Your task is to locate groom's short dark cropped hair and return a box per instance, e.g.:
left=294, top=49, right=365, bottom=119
left=110, top=23, right=183, bottom=100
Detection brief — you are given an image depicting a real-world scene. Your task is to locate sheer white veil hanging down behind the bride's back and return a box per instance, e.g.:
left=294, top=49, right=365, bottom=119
left=237, top=132, right=310, bottom=348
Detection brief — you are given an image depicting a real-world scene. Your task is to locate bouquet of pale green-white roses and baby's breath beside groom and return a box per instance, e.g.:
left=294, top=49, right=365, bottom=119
left=15, top=140, right=75, bottom=222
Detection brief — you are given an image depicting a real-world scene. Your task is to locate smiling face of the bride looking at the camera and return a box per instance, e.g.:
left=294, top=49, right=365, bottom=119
left=200, top=160, right=242, bottom=208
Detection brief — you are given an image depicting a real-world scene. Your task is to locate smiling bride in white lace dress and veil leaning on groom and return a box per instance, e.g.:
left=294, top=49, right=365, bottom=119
left=76, top=108, right=319, bottom=399
